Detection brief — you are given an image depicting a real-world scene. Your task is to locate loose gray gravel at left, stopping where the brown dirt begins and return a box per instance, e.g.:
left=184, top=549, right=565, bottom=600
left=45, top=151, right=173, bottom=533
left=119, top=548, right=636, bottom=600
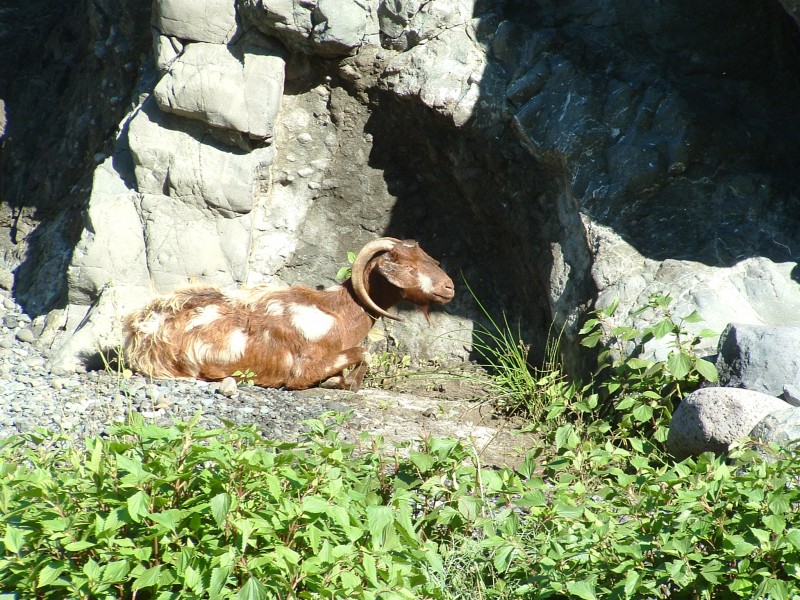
left=0, top=296, right=366, bottom=441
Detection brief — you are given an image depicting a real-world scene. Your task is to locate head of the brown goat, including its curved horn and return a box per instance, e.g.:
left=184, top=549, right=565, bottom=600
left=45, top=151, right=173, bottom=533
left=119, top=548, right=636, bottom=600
left=352, top=238, right=455, bottom=321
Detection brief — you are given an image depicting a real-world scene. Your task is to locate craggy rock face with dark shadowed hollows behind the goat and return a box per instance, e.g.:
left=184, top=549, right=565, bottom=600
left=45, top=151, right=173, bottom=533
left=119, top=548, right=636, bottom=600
left=0, top=0, right=800, bottom=376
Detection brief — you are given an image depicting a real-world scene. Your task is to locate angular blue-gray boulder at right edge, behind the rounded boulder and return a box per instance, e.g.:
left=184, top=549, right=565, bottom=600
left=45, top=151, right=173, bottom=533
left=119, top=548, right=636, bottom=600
left=717, top=323, right=800, bottom=402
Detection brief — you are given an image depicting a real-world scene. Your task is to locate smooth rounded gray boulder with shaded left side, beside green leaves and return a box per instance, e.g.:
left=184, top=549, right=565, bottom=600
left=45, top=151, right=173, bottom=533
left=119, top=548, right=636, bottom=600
left=667, top=387, right=789, bottom=460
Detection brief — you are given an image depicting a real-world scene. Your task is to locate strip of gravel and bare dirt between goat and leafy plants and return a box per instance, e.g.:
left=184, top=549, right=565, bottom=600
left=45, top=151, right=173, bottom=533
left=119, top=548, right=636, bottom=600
left=0, top=289, right=537, bottom=467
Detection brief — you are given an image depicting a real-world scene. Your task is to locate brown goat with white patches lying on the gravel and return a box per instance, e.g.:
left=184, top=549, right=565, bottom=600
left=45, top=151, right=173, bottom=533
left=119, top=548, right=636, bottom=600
left=123, top=238, right=455, bottom=391
